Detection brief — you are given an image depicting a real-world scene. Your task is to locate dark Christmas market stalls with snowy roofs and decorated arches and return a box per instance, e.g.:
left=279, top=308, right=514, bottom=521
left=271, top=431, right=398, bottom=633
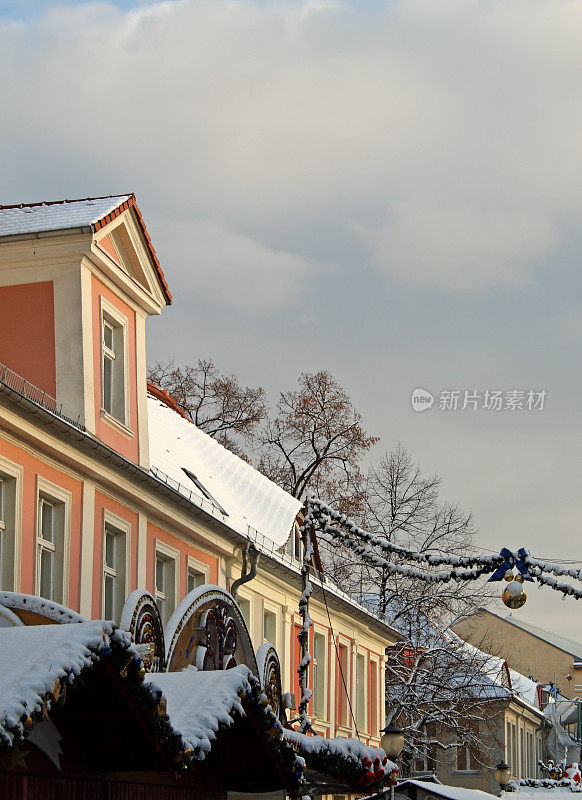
left=0, top=586, right=394, bottom=800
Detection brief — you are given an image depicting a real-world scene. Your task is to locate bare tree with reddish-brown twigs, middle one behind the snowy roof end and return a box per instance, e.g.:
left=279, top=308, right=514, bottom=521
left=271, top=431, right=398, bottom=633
left=258, top=371, right=378, bottom=513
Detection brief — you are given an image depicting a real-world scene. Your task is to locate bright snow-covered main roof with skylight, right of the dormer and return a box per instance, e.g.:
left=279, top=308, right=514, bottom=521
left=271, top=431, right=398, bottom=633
left=148, top=395, right=301, bottom=546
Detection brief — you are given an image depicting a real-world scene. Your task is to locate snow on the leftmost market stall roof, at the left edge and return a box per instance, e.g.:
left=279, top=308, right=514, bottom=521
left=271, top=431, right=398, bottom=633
left=0, top=620, right=130, bottom=745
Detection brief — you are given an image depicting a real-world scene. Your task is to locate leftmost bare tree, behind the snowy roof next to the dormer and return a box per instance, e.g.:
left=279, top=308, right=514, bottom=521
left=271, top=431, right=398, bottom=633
left=148, top=359, right=267, bottom=458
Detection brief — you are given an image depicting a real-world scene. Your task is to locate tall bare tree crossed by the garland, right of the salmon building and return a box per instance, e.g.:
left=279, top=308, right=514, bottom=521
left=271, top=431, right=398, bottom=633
left=319, top=445, right=498, bottom=767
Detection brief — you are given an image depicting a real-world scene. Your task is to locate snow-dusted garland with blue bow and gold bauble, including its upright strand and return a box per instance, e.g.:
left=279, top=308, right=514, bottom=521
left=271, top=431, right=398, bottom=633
left=297, top=495, right=582, bottom=732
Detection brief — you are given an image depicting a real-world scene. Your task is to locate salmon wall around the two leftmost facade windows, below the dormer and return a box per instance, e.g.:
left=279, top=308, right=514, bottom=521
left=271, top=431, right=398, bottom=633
left=0, top=439, right=83, bottom=611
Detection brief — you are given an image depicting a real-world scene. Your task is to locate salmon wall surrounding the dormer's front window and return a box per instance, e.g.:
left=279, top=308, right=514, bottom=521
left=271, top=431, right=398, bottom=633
left=91, top=276, right=139, bottom=462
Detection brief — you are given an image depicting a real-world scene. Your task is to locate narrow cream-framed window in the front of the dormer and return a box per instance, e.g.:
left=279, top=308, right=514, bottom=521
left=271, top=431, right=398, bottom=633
left=101, top=298, right=127, bottom=425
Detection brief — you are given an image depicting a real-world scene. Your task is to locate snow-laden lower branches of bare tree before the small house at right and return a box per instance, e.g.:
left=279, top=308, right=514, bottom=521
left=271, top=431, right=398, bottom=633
left=386, top=617, right=509, bottom=774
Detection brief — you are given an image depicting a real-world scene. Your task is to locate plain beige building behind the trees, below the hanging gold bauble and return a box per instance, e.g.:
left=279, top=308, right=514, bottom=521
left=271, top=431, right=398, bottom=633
left=454, top=608, right=582, bottom=698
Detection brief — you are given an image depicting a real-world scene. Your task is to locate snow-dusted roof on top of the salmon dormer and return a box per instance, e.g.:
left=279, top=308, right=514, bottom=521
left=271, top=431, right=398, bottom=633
left=0, top=194, right=131, bottom=236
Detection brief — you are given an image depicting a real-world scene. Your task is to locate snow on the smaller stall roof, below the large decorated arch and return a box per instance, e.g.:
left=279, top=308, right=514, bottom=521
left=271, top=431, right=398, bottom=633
left=145, top=664, right=251, bottom=760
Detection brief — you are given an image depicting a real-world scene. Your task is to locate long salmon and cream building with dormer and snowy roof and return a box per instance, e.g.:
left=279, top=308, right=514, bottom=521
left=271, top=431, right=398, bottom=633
left=0, top=195, right=396, bottom=764
